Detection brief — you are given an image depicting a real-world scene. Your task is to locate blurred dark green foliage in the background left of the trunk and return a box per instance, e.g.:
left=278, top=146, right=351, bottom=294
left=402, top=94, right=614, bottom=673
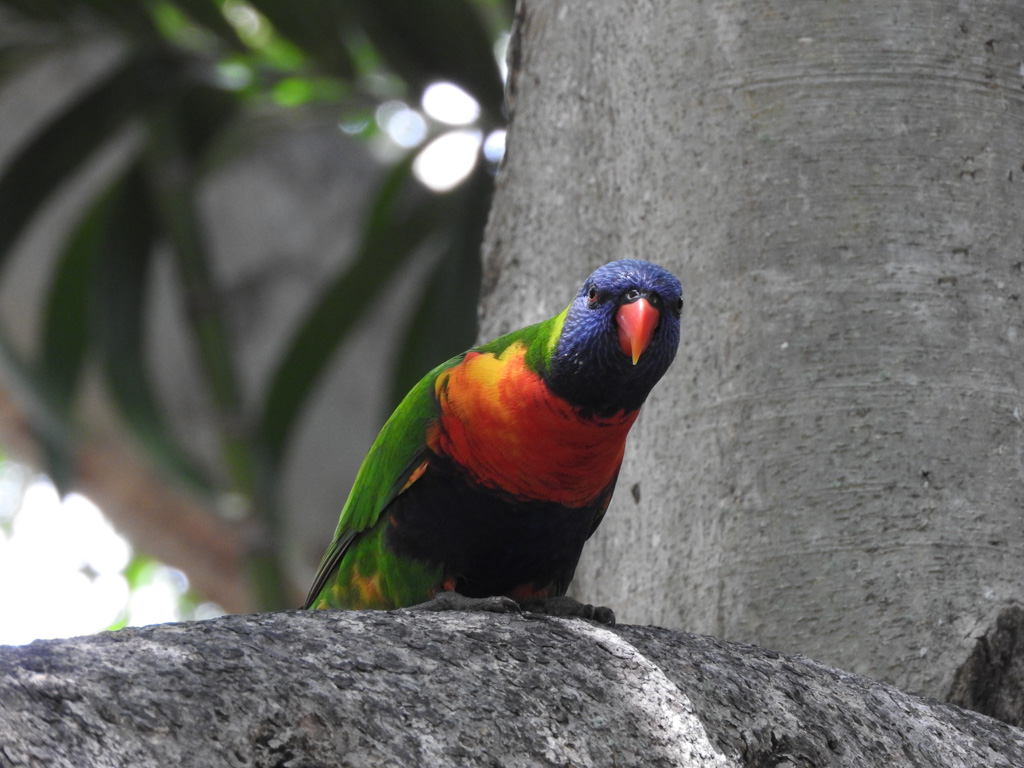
left=0, top=0, right=513, bottom=608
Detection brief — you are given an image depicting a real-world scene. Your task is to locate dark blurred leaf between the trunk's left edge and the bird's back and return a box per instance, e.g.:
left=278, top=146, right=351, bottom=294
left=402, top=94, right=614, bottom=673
left=387, top=166, right=494, bottom=413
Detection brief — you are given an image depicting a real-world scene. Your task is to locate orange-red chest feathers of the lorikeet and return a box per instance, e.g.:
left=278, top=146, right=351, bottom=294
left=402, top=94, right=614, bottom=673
left=427, top=343, right=639, bottom=507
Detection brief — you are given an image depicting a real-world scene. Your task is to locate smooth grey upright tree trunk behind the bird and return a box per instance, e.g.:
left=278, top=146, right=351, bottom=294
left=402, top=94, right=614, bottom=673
left=482, top=0, right=1024, bottom=708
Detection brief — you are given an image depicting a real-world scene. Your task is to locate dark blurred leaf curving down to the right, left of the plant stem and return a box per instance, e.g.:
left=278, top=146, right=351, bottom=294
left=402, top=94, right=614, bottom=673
left=92, top=165, right=211, bottom=489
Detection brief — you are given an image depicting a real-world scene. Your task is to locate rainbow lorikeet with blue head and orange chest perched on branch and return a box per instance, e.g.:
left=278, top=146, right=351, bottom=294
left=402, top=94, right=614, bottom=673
left=305, top=259, right=683, bottom=623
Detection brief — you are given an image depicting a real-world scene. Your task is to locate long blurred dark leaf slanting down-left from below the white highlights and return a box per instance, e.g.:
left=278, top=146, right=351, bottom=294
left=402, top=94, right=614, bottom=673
left=260, top=156, right=441, bottom=464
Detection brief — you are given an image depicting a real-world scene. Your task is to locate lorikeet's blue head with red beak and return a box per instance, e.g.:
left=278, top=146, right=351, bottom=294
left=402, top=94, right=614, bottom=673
left=544, top=259, right=683, bottom=415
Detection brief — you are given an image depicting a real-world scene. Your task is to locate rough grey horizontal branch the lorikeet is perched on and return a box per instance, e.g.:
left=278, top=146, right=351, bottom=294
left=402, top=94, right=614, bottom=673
left=0, top=611, right=1024, bottom=768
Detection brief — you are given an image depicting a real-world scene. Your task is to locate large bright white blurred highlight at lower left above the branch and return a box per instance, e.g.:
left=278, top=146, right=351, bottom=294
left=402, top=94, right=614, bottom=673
left=0, top=464, right=220, bottom=644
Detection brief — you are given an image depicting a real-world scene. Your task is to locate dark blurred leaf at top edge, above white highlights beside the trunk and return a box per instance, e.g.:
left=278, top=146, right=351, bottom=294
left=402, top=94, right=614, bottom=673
left=352, top=0, right=504, bottom=123
